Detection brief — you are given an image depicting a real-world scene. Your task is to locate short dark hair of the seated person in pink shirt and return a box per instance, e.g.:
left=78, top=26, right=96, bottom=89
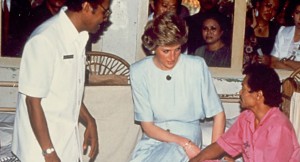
left=243, top=64, right=282, bottom=107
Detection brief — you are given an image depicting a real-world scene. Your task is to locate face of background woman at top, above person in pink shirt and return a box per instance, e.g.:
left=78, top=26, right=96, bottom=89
left=258, top=0, right=279, bottom=21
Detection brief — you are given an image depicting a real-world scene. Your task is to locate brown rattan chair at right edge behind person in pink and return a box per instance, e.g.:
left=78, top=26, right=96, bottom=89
left=281, top=68, right=300, bottom=117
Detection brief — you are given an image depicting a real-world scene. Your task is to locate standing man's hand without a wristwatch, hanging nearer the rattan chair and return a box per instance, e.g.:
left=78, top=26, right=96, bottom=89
left=83, top=119, right=99, bottom=158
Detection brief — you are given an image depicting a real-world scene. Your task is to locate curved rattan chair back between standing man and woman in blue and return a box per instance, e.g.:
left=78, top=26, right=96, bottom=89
left=86, top=51, right=130, bottom=85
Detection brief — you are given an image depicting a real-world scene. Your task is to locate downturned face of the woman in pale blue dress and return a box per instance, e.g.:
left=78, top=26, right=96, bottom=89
left=154, top=44, right=181, bottom=70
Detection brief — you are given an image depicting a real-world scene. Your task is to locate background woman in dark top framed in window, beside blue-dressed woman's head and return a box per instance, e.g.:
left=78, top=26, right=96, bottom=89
left=195, top=13, right=231, bottom=67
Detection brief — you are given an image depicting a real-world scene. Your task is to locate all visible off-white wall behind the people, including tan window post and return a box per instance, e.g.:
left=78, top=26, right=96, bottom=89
left=0, top=0, right=291, bottom=106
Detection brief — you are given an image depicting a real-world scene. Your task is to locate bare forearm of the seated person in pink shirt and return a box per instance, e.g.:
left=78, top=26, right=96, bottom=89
left=190, top=142, right=225, bottom=162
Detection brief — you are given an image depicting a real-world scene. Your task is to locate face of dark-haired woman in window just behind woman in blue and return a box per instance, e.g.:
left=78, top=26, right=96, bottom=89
left=202, top=19, right=223, bottom=44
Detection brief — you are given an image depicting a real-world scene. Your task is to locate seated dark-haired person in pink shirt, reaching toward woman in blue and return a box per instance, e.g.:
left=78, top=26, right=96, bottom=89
left=190, top=64, right=300, bottom=162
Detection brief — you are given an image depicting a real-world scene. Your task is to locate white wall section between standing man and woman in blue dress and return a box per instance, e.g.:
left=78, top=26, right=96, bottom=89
left=92, top=0, right=148, bottom=64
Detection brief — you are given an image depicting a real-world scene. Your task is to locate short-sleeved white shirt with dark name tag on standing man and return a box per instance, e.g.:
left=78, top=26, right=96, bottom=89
left=12, top=7, right=88, bottom=162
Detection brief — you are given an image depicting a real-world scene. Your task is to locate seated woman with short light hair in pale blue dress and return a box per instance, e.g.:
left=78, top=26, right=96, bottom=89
left=130, top=12, right=225, bottom=162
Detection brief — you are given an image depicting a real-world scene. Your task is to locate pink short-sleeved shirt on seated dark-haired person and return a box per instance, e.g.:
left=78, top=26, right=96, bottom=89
left=217, top=107, right=300, bottom=162
